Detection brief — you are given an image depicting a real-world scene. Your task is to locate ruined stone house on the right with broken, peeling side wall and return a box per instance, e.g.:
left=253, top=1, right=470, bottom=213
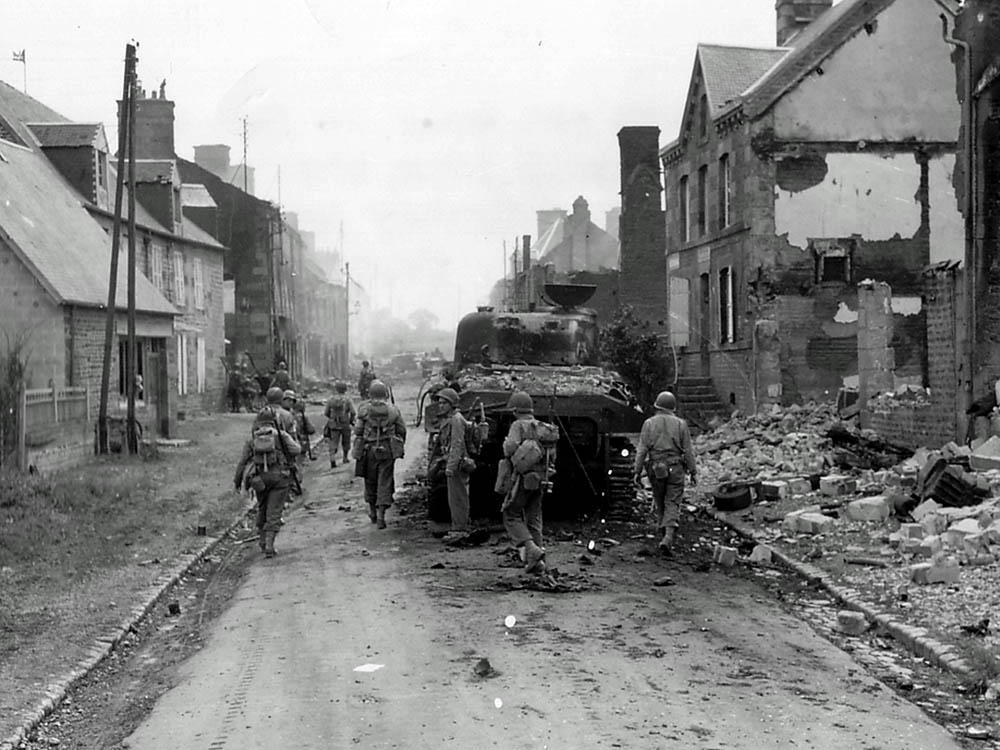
left=660, top=0, right=963, bottom=422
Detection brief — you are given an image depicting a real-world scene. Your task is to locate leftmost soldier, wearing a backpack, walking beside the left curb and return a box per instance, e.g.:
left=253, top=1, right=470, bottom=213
left=233, top=388, right=300, bottom=557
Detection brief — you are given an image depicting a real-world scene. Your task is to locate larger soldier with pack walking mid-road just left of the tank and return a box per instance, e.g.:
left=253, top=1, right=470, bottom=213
left=354, top=380, right=406, bottom=529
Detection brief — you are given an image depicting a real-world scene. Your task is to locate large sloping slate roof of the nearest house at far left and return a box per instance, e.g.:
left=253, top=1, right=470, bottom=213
left=0, top=82, right=177, bottom=315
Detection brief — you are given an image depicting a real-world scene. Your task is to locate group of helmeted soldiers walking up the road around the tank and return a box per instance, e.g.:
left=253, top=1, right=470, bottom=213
left=234, top=363, right=697, bottom=573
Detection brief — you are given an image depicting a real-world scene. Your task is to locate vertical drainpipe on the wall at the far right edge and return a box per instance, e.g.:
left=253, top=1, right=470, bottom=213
left=941, top=13, right=979, bottom=428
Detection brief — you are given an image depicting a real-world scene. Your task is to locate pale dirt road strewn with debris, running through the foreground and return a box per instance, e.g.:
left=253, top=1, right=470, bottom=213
left=113, top=412, right=958, bottom=750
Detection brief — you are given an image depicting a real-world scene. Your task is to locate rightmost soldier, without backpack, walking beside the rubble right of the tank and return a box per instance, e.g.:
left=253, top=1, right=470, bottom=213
left=634, top=391, right=698, bottom=555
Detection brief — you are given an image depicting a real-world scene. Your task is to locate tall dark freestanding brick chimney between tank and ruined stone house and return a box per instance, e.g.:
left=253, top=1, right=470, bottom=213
left=618, top=125, right=668, bottom=333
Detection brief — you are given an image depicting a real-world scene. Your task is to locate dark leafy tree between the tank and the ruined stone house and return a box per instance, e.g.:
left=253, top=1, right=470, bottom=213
left=600, top=305, right=675, bottom=409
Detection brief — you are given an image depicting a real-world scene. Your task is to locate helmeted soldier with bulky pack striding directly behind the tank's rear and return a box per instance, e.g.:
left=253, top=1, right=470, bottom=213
left=498, top=391, right=559, bottom=573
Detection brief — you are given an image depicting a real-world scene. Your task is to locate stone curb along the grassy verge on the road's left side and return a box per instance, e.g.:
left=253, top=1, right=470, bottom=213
left=0, top=511, right=254, bottom=750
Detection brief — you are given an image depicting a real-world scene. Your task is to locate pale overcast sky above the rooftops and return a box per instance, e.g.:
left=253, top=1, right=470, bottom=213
left=0, top=0, right=775, bottom=325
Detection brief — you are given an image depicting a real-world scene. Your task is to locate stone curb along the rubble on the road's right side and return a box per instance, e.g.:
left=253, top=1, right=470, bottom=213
left=716, top=511, right=972, bottom=680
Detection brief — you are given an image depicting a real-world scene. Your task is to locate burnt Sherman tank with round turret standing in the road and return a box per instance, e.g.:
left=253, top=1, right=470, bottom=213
left=420, top=284, right=643, bottom=518
